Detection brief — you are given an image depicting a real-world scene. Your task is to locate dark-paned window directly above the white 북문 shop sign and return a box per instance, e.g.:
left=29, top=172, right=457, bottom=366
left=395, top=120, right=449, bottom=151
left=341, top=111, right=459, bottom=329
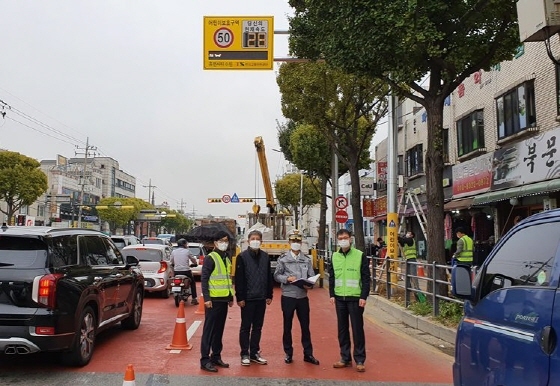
left=496, top=81, right=537, bottom=139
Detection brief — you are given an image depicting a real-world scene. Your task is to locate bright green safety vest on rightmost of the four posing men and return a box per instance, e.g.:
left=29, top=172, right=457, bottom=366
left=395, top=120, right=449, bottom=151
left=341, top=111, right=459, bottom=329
left=332, top=248, right=362, bottom=297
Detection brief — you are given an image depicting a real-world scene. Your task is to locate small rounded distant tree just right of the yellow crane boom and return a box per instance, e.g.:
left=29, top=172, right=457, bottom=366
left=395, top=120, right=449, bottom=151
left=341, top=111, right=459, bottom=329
left=275, top=173, right=321, bottom=229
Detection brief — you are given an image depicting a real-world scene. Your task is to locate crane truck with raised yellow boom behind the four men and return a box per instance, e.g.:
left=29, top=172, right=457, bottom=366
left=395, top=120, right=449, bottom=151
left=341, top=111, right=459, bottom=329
left=240, top=137, right=309, bottom=269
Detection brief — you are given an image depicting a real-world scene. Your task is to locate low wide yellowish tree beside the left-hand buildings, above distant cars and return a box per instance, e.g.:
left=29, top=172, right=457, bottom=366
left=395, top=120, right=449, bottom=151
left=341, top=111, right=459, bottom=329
left=96, top=197, right=153, bottom=234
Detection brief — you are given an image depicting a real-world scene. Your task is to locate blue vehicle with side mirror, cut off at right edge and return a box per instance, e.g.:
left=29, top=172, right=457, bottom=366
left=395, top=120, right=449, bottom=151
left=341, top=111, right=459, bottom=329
left=451, top=209, right=560, bottom=386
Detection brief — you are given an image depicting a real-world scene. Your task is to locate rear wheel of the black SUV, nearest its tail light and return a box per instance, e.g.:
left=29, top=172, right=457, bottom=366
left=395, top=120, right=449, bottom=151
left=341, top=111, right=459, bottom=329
left=62, top=306, right=97, bottom=366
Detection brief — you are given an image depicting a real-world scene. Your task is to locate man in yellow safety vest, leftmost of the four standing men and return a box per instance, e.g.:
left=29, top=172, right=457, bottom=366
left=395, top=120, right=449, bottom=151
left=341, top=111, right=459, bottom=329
left=200, top=231, right=233, bottom=373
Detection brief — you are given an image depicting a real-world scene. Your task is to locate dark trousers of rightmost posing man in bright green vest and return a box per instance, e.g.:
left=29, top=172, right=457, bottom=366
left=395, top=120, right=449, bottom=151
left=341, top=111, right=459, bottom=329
left=336, top=299, right=366, bottom=363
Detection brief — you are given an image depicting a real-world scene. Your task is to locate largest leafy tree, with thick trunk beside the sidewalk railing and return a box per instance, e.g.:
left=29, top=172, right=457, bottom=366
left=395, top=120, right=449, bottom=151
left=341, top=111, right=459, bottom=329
left=290, top=0, right=519, bottom=278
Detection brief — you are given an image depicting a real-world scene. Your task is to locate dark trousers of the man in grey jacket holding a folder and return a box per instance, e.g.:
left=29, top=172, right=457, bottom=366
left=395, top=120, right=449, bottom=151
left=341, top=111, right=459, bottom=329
left=280, top=296, right=313, bottom=356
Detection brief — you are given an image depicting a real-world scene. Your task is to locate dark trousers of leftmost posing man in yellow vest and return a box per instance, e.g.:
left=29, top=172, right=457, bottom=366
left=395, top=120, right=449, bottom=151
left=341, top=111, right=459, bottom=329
left=200, top=301, right=229, bottom=366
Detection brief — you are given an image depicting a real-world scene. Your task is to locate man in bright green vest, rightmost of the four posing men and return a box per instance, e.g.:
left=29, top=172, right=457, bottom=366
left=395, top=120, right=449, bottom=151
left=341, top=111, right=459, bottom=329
left=329, top=229, right=371, bottom=372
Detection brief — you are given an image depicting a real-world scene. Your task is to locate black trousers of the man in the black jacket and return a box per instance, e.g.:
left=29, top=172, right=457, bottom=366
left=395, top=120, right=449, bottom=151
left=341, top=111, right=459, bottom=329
left=239, top=299, right=266, bottom=357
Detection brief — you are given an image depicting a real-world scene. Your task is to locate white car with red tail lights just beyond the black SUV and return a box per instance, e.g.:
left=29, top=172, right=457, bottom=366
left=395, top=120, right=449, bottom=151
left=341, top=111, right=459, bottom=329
left=122, top=244, right=173, bottom=299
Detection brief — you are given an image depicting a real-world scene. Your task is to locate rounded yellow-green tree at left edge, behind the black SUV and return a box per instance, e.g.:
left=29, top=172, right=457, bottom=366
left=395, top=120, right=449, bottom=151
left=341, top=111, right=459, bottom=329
left=0, top=151, right=49, bottom=225
